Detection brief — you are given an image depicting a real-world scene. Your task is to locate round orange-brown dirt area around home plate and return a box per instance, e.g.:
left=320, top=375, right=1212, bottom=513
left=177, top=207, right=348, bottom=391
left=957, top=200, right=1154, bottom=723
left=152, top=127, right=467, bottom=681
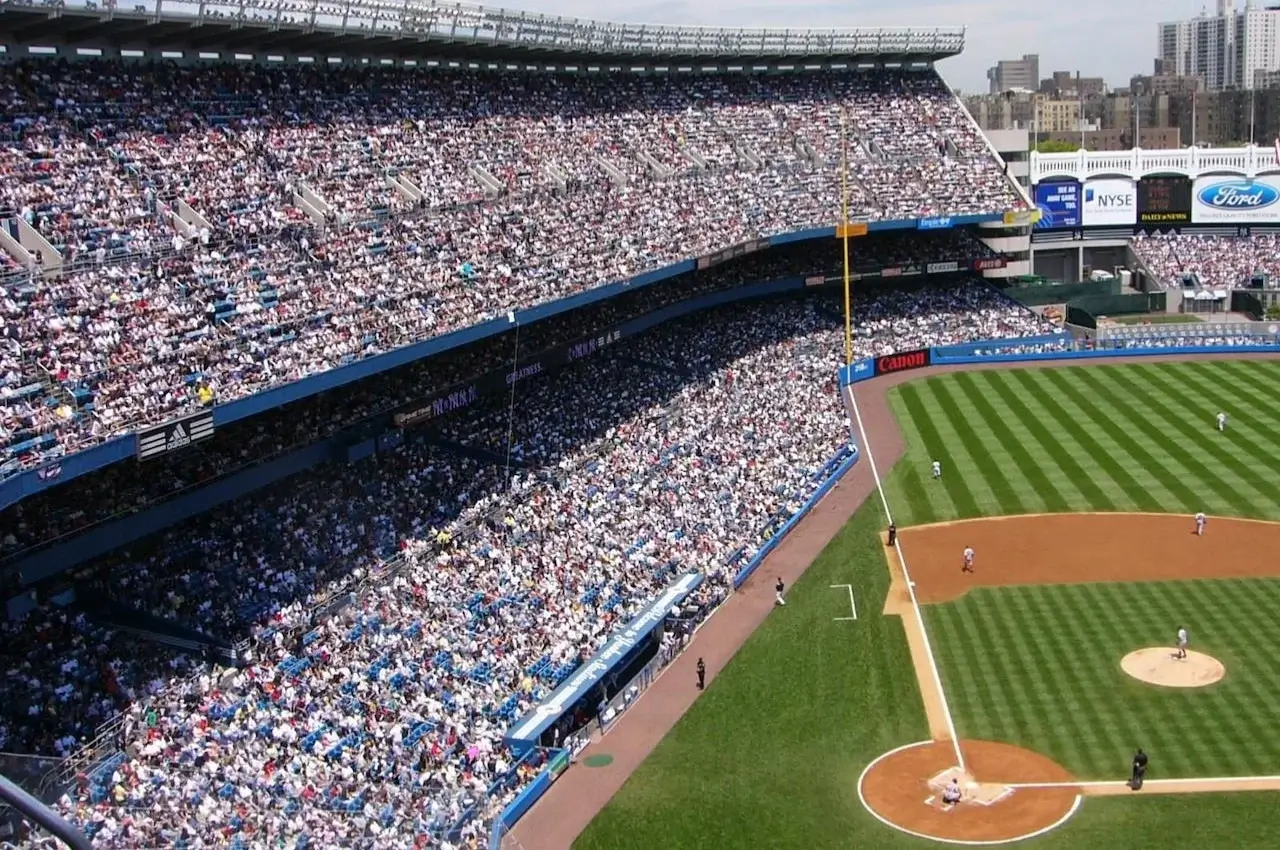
left=858, top=740, right=1080, bottom=845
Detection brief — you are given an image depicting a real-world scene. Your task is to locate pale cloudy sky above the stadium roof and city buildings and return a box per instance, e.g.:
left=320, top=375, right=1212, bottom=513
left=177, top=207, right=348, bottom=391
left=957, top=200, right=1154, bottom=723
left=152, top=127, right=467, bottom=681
left=495, top=0, right=1213, bottom=92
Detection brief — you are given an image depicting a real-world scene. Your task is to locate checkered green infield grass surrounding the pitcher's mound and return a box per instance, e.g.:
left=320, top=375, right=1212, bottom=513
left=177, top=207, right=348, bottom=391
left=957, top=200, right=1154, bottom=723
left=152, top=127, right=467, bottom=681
left=924, top=579, right=1280, bottom=780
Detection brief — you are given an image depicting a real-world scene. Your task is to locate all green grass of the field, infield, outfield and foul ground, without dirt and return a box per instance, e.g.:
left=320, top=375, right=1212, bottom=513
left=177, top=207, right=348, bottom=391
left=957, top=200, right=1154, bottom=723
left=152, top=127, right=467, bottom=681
left=575, top=362, right=1280, bottom=850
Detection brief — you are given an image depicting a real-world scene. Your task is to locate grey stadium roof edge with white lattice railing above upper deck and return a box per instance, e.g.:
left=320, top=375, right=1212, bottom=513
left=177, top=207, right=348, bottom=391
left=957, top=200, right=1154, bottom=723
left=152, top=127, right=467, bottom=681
left=0, top=0, right=965, bottom=67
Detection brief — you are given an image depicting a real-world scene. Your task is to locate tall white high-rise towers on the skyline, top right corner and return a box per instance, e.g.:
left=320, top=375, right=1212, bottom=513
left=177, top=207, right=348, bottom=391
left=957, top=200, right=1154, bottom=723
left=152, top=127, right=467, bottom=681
left=1156, top=0, right=1280, bottom=91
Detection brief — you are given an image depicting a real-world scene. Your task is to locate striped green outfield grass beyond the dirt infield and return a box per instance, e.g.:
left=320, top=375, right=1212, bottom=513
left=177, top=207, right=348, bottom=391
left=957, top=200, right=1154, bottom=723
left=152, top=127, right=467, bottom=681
left=873, top=361, right=1280, bottom=526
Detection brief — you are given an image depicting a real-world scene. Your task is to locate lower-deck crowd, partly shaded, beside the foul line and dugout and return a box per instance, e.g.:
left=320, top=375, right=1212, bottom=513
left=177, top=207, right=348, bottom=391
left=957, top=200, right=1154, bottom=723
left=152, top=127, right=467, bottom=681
left=0, top=282, right=1052, bottom=850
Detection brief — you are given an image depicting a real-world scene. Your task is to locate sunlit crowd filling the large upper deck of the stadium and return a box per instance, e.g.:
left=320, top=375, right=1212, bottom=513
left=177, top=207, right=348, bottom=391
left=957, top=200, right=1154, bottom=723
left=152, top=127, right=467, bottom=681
left=0, top=60, right=1023, bottom=467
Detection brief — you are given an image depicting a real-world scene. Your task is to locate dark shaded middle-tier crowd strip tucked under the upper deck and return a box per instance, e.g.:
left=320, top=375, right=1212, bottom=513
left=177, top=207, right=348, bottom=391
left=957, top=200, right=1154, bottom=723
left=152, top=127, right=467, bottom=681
left=0, top=230, right=991, bottom=555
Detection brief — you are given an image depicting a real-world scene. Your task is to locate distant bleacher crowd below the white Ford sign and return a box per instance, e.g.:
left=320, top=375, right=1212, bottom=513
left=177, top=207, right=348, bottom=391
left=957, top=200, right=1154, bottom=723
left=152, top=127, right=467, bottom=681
left=1133, top=233, right=1280, bottom=289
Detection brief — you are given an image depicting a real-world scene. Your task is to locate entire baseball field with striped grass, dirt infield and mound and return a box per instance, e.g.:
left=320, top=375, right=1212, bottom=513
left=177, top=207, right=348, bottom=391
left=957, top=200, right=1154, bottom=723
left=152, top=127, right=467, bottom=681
left=573, top=360, right=1280, bottom=850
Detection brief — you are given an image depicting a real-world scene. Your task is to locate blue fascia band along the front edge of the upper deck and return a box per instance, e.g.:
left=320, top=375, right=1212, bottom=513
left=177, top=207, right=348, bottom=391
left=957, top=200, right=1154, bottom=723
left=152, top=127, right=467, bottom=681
left=0, top=213, right=1004, bottom=509
